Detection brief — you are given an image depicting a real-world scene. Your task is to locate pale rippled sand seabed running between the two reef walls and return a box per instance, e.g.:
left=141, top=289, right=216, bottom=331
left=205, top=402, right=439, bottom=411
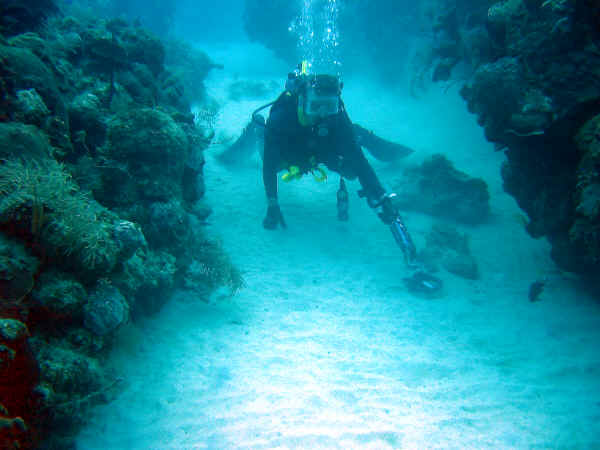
left=78, top=43, right=600, bottom=449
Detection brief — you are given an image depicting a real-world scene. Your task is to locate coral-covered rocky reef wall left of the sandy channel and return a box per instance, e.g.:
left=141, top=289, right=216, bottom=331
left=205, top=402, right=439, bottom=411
left=0, top=2, right=243, bottom=449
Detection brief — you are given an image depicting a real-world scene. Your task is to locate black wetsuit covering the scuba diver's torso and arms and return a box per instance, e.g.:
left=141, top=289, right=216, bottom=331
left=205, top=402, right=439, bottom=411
left=263, top=92, right=385, bottom=200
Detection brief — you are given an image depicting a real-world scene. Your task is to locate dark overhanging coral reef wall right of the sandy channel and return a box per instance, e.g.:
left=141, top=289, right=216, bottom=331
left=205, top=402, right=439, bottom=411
left=426, top=0, right=600, bottom=283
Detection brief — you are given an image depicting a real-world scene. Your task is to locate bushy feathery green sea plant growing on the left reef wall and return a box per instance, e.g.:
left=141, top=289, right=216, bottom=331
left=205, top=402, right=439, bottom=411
left=0, top=159, right=117, bottom=270
